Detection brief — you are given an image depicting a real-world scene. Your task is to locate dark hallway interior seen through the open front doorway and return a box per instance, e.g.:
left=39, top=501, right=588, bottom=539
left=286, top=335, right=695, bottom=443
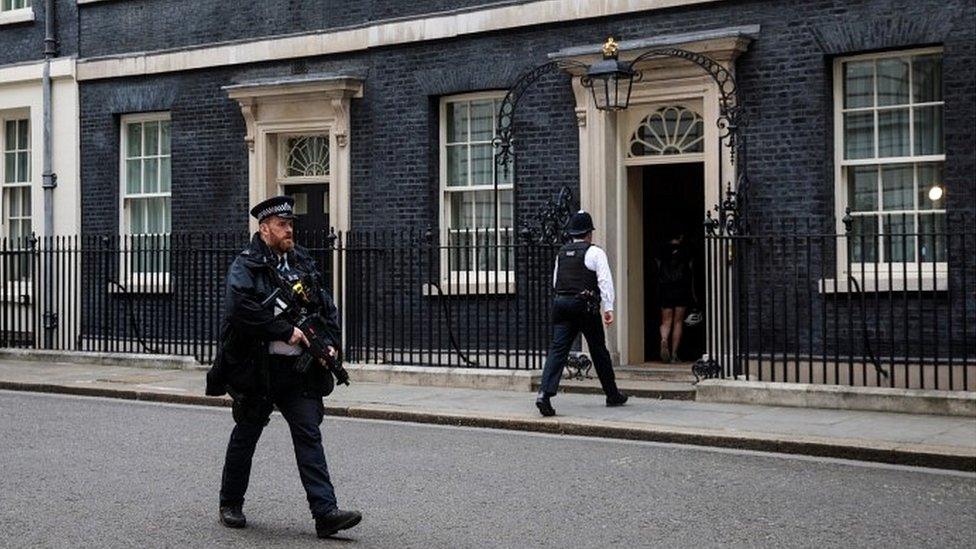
left=641, top=162, right=705, bottom=362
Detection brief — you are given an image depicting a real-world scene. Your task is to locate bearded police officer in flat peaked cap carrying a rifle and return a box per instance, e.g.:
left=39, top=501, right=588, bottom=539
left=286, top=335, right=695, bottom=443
left=207, top=196, right=362, bottom=537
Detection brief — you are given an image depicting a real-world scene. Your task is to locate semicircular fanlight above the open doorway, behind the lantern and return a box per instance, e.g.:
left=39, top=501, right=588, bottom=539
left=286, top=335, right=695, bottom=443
left=627, top=106, right=705, bottom=158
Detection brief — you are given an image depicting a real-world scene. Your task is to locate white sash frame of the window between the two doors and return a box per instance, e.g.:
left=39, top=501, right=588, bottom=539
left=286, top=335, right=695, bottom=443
left=436, top=91, right=515, bottom=295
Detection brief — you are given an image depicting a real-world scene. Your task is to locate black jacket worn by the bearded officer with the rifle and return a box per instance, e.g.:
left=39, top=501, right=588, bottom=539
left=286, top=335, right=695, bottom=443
left=206, top=233, right=341, bottom=397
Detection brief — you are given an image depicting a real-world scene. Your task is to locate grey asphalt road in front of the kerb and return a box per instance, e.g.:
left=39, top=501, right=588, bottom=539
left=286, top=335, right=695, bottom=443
left=0, top=391, right=976, bottom=548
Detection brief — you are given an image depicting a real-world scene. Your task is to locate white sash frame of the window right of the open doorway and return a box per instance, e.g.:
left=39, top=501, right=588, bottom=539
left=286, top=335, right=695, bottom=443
left=832, top=47, right=948, bottom=293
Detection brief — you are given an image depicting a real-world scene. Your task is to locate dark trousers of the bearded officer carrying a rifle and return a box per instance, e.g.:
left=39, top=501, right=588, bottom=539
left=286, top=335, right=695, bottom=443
left=220, top=358, right=336, bottom=517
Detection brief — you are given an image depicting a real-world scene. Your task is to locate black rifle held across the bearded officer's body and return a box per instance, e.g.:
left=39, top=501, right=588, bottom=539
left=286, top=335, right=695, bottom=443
left=265, top=268, right=349, bottom=385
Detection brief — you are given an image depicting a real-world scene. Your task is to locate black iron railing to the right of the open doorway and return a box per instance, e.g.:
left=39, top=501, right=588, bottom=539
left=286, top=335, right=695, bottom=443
left=706, top=214, right=976, bottom=390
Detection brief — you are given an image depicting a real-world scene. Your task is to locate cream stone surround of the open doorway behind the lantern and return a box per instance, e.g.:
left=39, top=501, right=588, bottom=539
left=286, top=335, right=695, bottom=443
left=554, top=28, right=758, bottom=364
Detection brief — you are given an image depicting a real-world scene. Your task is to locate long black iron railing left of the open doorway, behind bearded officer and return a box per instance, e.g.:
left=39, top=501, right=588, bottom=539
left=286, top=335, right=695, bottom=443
left=0, top=230, right=555, bottom=369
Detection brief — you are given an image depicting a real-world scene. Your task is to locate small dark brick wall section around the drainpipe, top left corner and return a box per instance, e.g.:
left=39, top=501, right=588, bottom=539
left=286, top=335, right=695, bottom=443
left=0, top=0, right=78, bottom=65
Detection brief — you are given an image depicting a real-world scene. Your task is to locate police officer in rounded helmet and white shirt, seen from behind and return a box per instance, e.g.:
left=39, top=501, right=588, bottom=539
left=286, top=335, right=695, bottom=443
left=535, top=210, right=627, bottom=417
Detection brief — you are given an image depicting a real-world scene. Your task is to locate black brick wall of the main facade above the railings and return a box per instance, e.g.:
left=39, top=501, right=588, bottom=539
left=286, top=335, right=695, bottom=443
left=81, top=0, right=976, bottom=368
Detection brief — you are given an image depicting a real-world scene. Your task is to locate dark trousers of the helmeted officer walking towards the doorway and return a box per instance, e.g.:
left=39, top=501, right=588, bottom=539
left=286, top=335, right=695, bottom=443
left=540, top=296, right=618, bottom=396
